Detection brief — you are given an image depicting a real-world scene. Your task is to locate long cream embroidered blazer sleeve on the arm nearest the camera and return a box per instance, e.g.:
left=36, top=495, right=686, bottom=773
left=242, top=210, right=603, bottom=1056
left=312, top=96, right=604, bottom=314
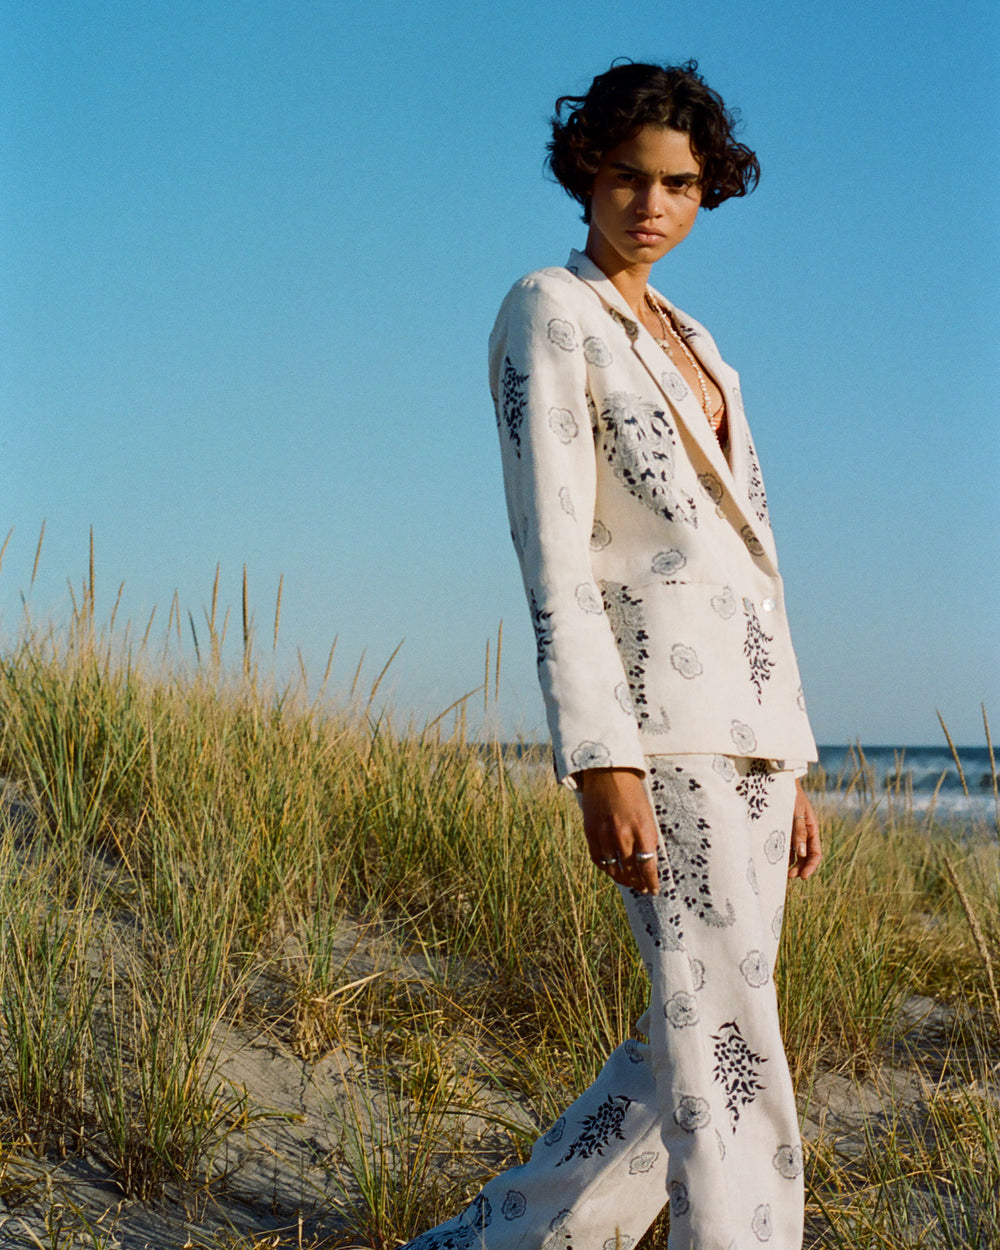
left=490, top=274, right=645, bottom=786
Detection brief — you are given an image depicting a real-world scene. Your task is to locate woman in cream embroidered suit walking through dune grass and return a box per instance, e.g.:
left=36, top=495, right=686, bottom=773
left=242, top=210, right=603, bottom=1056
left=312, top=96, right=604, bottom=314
left=411, top=63, right=820, bottom=1250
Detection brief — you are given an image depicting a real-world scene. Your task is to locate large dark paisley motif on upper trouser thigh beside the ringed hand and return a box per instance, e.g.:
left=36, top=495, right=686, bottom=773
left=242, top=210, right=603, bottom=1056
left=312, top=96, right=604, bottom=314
left=640, top=761, right=736, bottom=929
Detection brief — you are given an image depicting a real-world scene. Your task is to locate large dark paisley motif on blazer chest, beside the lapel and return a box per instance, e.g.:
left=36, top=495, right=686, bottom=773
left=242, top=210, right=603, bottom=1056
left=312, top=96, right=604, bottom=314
left=600, top=391, right=698, bottom=526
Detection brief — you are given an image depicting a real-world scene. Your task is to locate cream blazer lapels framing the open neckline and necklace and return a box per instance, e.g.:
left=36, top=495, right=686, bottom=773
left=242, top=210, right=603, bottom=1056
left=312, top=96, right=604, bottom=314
left=566, top=250, right=778, bottom=566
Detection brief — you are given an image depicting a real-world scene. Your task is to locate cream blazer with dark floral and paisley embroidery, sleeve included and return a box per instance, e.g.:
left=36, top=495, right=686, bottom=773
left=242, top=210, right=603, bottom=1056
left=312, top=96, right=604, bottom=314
left=490, top=251, right=816, bottom=784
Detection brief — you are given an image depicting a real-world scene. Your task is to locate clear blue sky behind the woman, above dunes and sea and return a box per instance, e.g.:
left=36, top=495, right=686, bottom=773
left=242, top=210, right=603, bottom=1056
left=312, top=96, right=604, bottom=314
left=0, top=0, right=1000, bottom=743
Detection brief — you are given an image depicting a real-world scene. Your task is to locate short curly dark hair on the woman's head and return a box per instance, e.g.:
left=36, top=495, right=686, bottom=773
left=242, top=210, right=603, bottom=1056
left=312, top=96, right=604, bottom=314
left=546, top=61, right=760, bottom=221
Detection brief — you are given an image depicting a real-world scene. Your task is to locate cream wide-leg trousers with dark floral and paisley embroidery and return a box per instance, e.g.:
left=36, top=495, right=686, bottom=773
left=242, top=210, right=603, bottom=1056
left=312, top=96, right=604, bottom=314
left=406, top=755, right=803, bottom=1250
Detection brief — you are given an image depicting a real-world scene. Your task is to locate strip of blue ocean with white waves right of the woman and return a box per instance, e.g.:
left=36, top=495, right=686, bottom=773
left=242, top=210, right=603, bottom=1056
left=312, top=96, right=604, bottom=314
left=813, top=745, right=1000, bottom=829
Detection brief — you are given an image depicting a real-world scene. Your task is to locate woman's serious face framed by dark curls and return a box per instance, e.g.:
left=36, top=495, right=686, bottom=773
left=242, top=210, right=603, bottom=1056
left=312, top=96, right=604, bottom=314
left=586, top=126, right=701, bottom=276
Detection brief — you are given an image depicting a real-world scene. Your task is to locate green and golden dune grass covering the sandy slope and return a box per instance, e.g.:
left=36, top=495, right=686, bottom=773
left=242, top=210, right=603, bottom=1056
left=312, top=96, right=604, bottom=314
left=0, top=560, right=1000, bottom=1250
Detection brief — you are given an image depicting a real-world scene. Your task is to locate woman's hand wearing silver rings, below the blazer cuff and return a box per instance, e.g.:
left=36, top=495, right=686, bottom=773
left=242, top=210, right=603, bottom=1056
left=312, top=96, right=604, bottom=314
left=575, top=769, right=660, bottom=894
